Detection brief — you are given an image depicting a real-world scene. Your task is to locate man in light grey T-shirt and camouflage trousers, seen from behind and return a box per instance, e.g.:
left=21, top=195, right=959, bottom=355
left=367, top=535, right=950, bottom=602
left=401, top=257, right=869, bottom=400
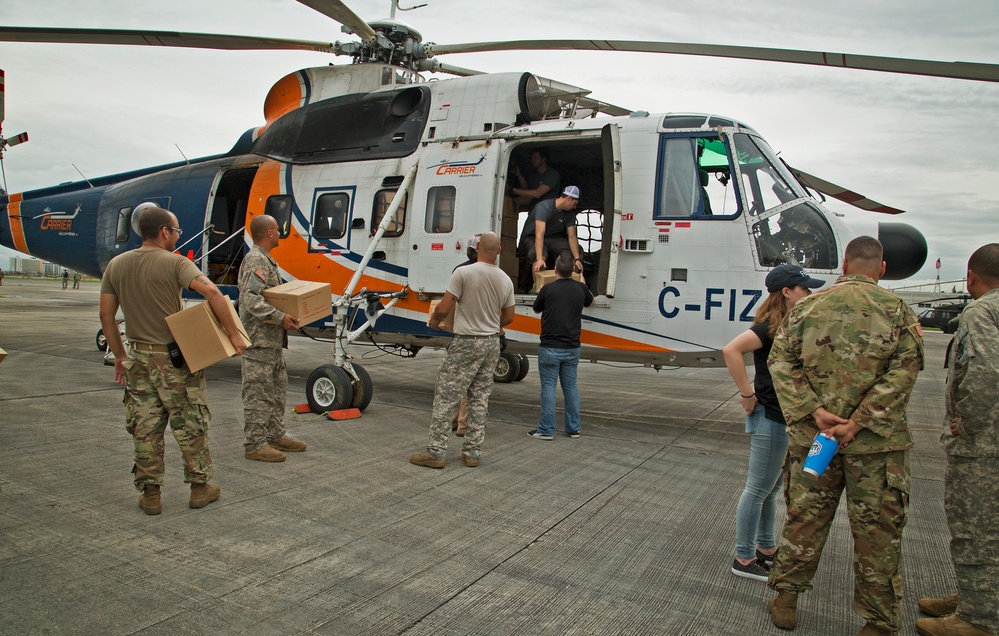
left=409, top=232, right=514, bottom=468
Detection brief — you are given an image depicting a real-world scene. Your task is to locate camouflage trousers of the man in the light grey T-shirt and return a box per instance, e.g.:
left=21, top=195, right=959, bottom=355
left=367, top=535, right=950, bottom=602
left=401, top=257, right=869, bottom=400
left=427, top=335, right=499, bottom=459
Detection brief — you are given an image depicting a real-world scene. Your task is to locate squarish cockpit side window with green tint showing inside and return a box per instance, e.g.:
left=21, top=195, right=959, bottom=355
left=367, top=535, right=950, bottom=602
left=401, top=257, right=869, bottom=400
left=654, top=136, right=739, bottom=219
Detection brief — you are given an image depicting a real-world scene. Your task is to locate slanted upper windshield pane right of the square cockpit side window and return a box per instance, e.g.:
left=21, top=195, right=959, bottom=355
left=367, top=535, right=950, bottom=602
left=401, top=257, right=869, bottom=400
left=735, top=133, right=808, bottom=215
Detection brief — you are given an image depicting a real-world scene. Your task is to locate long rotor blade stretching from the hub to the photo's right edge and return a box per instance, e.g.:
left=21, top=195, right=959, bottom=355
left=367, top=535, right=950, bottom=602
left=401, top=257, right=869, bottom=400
left=427, top=40, right=999, bottom=82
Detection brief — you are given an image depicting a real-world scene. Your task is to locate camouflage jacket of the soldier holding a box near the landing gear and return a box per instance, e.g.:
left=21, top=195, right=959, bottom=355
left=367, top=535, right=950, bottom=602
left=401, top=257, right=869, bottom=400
left=239, top=245, right=288, bottom=349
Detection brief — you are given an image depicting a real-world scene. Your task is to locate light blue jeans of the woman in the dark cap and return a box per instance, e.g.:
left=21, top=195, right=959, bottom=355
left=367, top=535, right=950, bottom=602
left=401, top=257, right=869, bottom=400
left=735, top=404, right=787, bottom=559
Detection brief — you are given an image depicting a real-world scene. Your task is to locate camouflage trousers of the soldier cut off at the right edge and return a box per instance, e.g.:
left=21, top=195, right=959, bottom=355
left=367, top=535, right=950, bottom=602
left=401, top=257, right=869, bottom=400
left=944, top=456, right=999, bottom=634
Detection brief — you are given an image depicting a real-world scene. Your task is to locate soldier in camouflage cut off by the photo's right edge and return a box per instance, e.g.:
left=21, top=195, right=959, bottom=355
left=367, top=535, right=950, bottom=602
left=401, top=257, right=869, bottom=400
left=916, top=243, right=999, bottom=636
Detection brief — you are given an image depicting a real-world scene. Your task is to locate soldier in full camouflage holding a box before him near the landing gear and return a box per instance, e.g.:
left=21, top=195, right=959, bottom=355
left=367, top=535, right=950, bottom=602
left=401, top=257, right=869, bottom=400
left=239, top=214, right=305, bottom=462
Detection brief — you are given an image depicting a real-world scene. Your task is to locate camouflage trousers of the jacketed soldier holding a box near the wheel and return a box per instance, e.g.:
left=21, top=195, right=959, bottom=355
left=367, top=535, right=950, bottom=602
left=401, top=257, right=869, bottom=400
left=242, top=348, right=288, bottom=453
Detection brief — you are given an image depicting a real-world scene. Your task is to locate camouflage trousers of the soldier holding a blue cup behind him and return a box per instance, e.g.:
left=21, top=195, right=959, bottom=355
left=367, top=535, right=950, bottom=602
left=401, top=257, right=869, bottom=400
left=770, top=444, right=910, bottom=631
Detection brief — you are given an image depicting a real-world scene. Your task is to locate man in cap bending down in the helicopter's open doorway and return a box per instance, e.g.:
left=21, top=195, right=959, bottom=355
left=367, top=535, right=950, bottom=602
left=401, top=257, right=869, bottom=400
left=517, top=186, right=583, bottom=294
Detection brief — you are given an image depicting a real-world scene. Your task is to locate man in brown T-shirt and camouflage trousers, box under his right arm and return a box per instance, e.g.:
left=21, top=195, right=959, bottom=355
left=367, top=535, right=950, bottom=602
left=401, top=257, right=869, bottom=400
left=100, top=203, right=246, bottom=515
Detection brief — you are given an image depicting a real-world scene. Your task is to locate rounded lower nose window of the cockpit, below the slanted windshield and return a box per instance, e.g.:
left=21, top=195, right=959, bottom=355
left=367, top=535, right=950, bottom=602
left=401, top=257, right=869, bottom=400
left=753, top=202, right=838, bottom=269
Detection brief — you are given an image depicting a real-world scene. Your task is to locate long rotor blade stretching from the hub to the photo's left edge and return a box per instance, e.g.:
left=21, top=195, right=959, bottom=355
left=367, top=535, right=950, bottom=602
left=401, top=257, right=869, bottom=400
left=0, top=27, right=338, bottom=55
